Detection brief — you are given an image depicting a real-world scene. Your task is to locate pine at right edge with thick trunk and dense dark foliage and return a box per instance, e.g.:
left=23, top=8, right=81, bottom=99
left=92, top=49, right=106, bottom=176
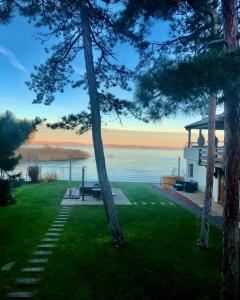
left=117, top=0, right=240, bottom=299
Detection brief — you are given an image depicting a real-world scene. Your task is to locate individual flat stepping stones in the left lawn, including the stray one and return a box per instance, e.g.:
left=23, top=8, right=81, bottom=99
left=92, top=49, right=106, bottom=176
left=5, top=206, right=72, bottom=299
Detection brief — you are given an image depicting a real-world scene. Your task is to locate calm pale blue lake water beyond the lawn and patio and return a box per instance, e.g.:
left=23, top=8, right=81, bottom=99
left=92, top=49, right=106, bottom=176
left=16, top=147, right=185, bottom=183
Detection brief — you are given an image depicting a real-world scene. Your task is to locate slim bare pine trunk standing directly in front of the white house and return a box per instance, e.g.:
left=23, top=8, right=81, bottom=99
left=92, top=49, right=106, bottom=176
left=199, top=95, right=216, bottom=248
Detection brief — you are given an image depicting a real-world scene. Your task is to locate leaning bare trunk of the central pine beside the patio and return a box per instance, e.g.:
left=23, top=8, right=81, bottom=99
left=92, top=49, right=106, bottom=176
left=80, top=4, right=124, bottom=247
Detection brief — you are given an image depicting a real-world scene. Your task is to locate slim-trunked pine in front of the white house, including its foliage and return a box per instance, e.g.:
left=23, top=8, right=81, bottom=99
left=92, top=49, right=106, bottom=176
left=119, top=0, right=220, bottom=248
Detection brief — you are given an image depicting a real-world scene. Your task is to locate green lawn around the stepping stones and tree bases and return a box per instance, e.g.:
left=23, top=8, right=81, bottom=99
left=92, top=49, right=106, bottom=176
left=0, top=182, right=221, bottom=300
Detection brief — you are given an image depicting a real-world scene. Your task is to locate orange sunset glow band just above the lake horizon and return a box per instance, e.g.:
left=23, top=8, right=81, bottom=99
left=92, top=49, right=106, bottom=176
left=29, top=125, right=218, bottom=149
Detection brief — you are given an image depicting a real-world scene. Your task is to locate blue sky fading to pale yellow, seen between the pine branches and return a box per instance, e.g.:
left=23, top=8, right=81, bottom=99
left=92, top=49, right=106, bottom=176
left=0, top=12, right=224, bottom=146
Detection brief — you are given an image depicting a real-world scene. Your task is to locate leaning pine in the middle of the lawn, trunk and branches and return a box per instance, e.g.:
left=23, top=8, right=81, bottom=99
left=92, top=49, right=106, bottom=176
left=18, top=0, right=139, bottom=247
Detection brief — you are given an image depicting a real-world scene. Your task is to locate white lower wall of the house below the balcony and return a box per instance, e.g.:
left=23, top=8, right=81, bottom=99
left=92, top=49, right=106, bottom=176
left=184, top=147, right=218, bottom=202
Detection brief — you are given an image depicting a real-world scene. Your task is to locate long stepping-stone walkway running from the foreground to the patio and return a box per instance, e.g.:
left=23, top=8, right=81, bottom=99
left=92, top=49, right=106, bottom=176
left=6, top=206, right=72, bottom=299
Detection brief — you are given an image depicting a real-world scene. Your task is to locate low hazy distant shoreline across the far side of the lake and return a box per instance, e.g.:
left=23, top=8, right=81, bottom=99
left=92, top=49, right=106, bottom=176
left=26, top=141, right=184, bottom=150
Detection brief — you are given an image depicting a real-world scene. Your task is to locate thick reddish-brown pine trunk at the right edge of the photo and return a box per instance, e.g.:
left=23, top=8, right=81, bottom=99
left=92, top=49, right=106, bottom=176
left=221, top=0, right=240, bottom=300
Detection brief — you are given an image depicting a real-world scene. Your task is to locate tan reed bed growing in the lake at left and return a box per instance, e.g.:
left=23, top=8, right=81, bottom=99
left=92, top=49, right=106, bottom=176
left=17, top=147, right=89, bottom=163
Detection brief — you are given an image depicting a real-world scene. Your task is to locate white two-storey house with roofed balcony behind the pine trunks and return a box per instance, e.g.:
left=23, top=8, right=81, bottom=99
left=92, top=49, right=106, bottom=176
left=184, top=114, right=224, bottom=204
